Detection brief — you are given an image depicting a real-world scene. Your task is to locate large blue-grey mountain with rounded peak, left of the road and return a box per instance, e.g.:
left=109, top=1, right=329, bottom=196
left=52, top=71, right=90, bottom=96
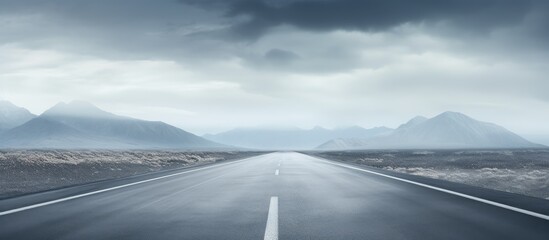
left=0, top=101, right=227, bottom=149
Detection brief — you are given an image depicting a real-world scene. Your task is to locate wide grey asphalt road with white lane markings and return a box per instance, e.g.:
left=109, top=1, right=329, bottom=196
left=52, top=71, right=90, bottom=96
left=0, top=152, right=549, bottom=240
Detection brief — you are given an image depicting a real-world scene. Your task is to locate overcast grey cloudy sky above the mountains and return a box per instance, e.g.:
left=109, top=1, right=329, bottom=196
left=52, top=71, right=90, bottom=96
left=0, top=0, right=549, bottom=142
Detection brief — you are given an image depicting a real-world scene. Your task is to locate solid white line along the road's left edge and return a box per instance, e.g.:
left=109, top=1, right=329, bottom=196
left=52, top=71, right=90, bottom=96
left=0, top=158, right=256, bottom=216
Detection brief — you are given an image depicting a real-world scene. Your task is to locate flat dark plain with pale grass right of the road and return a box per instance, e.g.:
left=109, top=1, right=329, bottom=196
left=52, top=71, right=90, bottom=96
left=305, top=148, right=549, bottom=200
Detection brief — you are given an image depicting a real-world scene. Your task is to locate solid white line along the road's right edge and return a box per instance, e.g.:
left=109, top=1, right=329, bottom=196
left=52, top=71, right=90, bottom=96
left=316, top=158, right=549, bottom=220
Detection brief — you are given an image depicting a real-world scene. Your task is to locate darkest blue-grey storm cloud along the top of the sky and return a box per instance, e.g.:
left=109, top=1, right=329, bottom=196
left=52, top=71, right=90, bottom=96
left=185, top=0, right=547, bottom=38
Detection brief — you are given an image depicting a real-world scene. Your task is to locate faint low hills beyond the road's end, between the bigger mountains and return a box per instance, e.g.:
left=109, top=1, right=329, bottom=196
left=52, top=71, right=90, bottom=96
left=203, top=126, right=393, bottom=150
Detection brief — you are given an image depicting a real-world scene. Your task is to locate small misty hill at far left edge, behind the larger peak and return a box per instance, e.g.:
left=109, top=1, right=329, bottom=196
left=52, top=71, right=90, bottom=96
left=0, top=101, right=36, bottom=132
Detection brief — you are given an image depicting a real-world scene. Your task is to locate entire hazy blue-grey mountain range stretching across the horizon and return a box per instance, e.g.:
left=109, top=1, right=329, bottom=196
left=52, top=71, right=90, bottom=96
left=0, top=101, right=544, bottom=150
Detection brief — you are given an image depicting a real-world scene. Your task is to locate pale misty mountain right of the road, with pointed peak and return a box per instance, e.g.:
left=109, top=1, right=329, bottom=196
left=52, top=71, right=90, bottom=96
left=317, top=112, right=543, bottom=150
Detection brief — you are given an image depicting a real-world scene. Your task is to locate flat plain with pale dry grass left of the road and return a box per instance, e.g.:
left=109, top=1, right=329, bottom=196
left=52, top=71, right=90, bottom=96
left=0, top=149, right=265, bottom=199
